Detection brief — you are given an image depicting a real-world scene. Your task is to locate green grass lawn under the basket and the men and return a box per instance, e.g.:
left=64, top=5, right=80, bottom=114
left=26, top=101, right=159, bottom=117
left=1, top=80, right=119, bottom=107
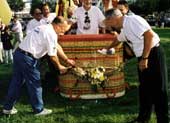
left=0, top=29, right=170, bottom=123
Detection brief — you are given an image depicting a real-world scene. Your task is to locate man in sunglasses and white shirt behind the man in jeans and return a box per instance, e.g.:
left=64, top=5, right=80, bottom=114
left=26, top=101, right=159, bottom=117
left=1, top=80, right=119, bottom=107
left=26, top=8, right=43, bottom=34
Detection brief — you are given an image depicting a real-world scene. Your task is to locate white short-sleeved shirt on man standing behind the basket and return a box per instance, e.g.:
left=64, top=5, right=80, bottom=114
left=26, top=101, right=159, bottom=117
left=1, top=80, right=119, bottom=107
left=71, top=6, right=105, bottom=34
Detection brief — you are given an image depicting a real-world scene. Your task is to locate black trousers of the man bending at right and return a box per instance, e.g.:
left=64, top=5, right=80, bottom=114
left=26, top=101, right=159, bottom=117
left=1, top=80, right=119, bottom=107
left=138, top=46, right=168, bottom=123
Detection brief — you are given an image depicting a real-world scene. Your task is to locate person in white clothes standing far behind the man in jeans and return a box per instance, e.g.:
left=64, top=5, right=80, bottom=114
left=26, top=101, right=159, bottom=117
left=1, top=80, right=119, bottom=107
left=11, top=15, right=23, bottom=51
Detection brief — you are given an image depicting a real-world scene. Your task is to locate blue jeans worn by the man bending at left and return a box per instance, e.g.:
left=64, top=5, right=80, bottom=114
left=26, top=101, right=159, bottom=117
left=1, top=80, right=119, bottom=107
left=4, top=50, right=43, bottom=113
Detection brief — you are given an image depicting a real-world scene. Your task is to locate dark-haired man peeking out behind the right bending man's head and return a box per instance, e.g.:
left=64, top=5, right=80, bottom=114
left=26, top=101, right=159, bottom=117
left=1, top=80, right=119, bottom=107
left=117, top=0, right=134, bottom=15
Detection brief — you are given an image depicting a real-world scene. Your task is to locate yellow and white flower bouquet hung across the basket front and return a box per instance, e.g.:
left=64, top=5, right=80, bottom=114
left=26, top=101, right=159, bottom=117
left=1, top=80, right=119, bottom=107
left=70, top=65, right=123, bottom=92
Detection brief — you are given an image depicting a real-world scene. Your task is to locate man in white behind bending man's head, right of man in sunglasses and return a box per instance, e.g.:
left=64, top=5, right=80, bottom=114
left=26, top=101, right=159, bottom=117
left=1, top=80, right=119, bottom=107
left=42, top=3, right=56, bottom=24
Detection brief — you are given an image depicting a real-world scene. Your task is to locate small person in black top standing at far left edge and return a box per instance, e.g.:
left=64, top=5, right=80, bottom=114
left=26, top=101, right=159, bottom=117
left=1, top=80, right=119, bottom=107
left=1, top=26, right=13, bottom=64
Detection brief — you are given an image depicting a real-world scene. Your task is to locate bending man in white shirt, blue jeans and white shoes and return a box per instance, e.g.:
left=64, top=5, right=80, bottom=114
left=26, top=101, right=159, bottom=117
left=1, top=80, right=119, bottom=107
left=3, top=17, right=75, bottom=116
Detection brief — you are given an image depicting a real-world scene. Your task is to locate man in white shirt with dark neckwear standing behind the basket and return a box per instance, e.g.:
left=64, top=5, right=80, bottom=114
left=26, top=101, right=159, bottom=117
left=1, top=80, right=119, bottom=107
left=71, top=0, right=105, bottom=34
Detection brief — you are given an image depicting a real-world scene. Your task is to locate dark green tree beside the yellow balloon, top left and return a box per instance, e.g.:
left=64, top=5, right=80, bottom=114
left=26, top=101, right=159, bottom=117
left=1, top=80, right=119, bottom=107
left=7, top=0, right=25, bottom=12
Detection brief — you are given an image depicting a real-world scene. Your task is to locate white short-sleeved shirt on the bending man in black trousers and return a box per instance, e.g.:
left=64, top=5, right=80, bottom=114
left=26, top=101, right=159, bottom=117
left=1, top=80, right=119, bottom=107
left=118, top=15, right=160, bottom=57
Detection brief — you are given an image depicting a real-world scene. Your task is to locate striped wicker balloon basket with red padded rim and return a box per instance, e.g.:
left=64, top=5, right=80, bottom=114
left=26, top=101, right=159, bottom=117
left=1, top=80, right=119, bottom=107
left=59, top=34, right=126, bottom=99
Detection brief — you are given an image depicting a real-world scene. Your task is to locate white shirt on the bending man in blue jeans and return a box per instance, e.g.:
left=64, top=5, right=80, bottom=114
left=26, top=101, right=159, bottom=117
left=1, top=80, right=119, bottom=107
left=19, top=24, right=58, bottom=59
